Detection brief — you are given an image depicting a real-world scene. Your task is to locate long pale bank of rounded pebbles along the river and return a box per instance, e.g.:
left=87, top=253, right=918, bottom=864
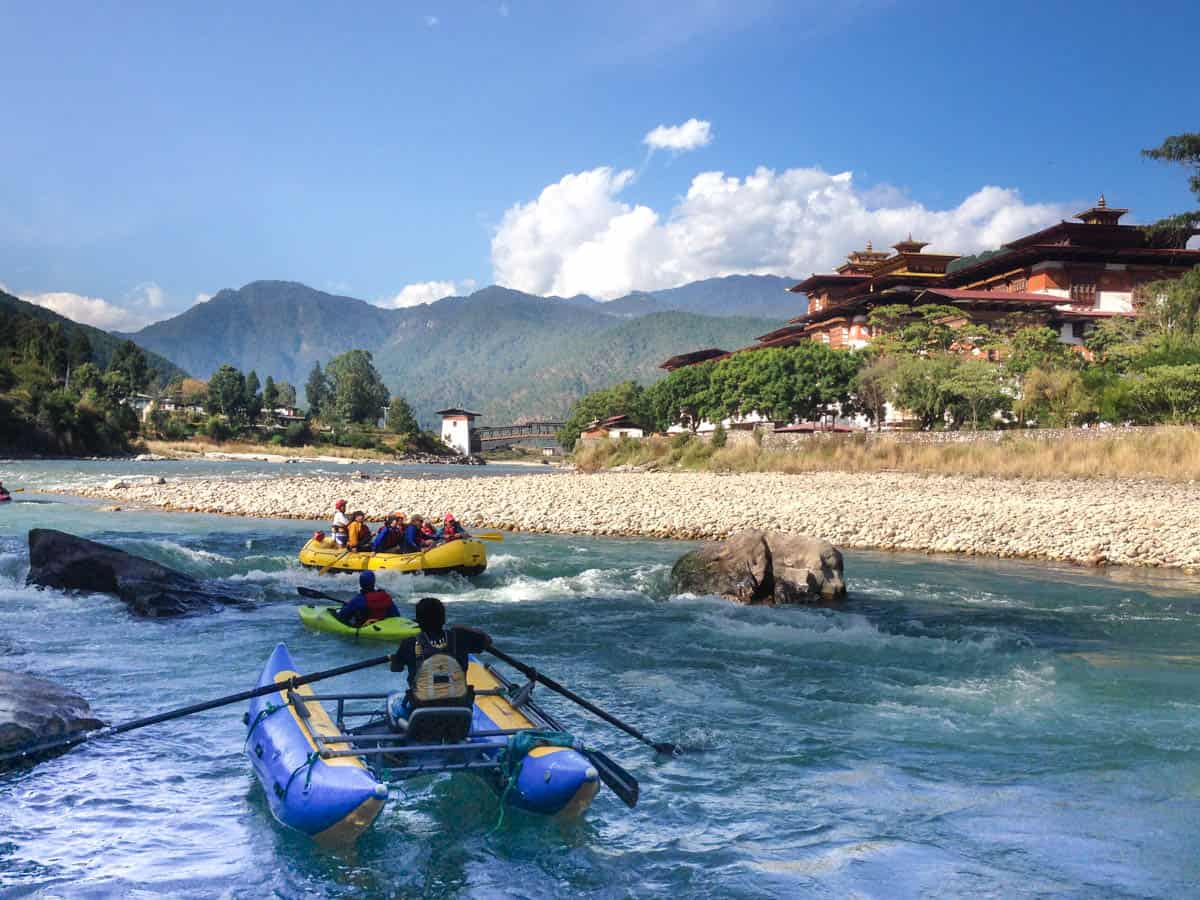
left=58, top=472, right=1200, bottom=570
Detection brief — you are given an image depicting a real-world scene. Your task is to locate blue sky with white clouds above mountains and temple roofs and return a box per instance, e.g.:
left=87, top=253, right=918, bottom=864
left=0, top=0, right=1200, bottom=328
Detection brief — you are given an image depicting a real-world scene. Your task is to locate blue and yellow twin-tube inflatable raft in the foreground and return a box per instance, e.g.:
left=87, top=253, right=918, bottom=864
left=246, top=643, right=600, bottom=844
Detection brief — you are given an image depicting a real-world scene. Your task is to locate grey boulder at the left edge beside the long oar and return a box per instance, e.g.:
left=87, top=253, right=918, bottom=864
left=0, top=668, right=104, bottom=772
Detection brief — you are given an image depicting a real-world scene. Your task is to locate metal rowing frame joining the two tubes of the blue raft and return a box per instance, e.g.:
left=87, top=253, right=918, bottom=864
left=278, top=664, right=562, bottom=786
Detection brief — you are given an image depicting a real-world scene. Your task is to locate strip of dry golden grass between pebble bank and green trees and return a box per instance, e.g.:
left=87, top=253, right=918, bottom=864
left=574, top=426, right=1200, bottom=481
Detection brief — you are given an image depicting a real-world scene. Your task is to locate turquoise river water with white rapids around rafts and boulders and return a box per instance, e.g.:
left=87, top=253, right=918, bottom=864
left=0, top=462, right=1200, bottom=898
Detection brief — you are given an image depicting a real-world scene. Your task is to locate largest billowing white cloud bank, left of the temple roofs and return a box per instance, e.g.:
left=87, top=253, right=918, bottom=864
left=492, top=167, right=1069, bottom=299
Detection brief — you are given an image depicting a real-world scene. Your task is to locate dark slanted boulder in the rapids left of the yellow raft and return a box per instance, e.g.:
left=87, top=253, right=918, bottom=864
left=26, top=528, right=242, bottom=617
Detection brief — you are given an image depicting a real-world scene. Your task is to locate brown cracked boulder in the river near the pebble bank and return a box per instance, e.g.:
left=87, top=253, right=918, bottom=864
left=671, top=532, right=846, bottom=606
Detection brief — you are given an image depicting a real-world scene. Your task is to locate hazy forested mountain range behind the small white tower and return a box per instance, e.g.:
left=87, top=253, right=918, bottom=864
left=126, top=276, right=803, bottom=424
